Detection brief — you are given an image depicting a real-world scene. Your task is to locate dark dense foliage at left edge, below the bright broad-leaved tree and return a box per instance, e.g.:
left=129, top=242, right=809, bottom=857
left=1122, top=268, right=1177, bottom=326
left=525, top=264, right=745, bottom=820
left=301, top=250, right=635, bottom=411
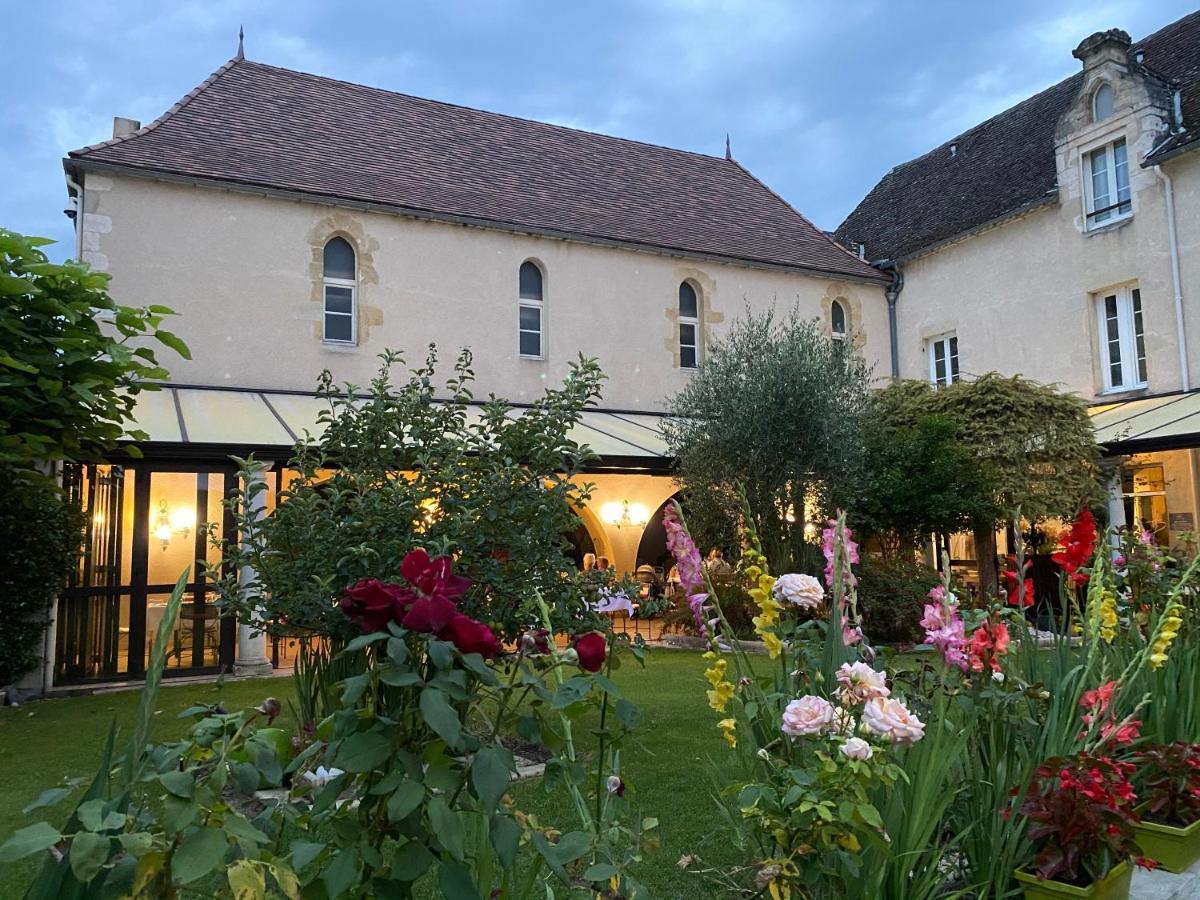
left=0, top=479, right=83, bottom=685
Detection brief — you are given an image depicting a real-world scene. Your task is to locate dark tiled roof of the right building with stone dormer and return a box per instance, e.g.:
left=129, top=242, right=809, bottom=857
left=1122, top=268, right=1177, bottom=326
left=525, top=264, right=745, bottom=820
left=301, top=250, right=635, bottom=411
left=835, top=12, right=1200, bottom=259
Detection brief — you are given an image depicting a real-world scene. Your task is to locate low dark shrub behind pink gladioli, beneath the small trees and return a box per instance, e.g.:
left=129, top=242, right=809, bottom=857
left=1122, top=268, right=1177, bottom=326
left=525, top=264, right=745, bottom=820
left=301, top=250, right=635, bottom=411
left=858, top=557, right=941, bottom=643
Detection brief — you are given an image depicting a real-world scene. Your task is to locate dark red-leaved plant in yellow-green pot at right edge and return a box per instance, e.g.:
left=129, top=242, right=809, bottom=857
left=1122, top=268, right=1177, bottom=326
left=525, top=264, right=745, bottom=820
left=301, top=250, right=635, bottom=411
left=1135, top=742, right=1200, bottom=872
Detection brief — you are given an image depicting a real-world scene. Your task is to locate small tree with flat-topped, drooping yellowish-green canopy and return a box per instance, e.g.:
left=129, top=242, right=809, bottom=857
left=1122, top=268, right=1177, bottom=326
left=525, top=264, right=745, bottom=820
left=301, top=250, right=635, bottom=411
left=872, top=372, right=1099, bottom=593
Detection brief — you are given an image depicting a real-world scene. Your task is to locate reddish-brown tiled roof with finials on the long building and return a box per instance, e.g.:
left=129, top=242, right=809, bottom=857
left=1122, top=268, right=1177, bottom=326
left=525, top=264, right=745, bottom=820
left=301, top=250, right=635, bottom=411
left=70, top=59, right=883, bottom=280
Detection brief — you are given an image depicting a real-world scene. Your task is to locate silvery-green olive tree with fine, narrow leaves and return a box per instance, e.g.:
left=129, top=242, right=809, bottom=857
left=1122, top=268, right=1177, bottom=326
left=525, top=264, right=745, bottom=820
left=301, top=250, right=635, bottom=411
left=664, top=310, right=870, bottom=569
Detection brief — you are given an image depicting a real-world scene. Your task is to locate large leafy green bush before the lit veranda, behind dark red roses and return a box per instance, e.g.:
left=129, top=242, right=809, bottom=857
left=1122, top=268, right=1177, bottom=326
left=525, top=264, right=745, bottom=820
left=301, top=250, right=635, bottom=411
left=214, top=347, right=602, bottom=638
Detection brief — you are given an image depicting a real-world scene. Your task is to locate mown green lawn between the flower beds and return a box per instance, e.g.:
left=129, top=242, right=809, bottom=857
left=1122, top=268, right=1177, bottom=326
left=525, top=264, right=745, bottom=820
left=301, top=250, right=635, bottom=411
left=0, top=650, right=739, bottom=898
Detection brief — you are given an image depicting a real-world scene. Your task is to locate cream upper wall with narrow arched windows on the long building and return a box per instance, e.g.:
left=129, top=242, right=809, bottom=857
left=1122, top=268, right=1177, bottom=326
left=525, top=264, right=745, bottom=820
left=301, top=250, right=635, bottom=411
left=83, top=173, right=889, bottom=410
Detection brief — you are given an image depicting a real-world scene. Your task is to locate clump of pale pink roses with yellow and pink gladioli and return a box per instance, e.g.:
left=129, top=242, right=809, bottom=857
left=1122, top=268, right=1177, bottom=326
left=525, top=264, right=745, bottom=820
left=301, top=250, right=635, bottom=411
left=666, top=509, right=925, bottom=900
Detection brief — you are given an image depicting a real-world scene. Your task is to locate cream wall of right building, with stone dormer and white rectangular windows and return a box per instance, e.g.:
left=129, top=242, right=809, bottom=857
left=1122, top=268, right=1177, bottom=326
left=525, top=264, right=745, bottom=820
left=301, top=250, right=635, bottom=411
left=898, top=63, right=1200, bottom=400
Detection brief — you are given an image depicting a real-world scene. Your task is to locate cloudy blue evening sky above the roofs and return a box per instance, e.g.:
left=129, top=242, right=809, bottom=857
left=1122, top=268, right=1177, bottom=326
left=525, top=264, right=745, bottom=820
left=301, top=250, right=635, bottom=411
left=0, top=0, right=1195, bottom=258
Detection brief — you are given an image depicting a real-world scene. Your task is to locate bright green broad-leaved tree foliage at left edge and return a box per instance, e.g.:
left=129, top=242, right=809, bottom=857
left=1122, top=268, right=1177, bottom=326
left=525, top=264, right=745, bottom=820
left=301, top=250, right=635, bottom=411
left=0, top=228, right=188, bottom=472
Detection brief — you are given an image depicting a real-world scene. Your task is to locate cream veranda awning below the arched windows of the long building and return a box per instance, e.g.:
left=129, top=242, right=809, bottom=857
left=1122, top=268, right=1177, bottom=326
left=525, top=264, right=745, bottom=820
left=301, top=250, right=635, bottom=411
left=134, top=386, right=670, bottom=468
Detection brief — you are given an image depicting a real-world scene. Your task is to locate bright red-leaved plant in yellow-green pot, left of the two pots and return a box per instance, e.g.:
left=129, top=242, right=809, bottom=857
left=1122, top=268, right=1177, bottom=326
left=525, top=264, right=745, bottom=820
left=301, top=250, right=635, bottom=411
left=1015, top=752, right=1138, bottom=900
